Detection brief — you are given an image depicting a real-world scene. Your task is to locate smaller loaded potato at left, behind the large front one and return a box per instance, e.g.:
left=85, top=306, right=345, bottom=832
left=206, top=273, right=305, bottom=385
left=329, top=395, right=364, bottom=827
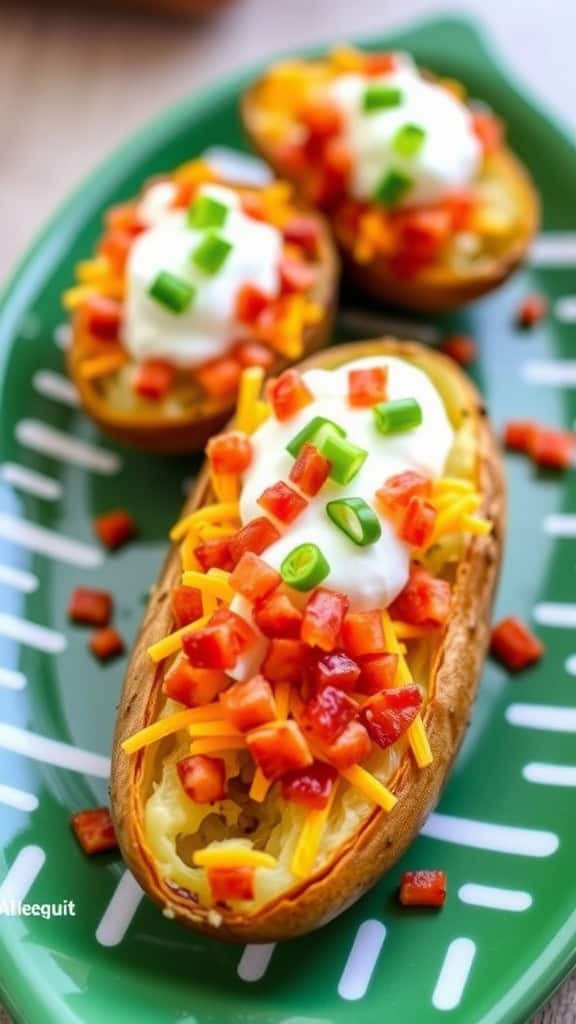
left=65, top=160, right=338, bottom=452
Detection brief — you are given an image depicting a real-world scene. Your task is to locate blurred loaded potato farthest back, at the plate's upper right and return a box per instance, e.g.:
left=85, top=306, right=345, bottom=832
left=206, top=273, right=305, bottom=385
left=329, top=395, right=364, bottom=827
left=242, top=48, right=538, bottom=311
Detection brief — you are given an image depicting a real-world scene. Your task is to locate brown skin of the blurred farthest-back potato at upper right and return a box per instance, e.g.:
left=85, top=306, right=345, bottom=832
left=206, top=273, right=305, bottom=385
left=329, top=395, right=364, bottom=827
left=241, top=81, right=540, bottom=313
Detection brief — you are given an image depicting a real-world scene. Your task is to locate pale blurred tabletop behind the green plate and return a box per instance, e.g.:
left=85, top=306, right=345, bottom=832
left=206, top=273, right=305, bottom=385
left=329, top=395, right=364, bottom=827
left=0, top=0, right=576, bottom=1024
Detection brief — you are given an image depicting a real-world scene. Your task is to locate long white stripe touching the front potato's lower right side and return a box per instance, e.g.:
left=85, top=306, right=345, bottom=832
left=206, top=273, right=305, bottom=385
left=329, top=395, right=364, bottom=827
left=420, top=814, right=559, bottom=857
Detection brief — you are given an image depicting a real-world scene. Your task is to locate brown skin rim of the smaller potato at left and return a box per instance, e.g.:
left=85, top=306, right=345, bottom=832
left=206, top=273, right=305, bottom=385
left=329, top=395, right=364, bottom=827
left=67, top=195, right=340, bottom=454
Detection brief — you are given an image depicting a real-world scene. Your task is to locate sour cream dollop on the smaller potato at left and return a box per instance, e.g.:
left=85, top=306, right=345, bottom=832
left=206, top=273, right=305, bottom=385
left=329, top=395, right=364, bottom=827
left=123, top=182, right=282, bottom=368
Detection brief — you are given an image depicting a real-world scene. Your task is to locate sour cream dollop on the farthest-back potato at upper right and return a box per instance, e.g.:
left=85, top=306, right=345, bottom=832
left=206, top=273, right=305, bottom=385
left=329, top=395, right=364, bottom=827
left=328, top=54, right=482, bottom=207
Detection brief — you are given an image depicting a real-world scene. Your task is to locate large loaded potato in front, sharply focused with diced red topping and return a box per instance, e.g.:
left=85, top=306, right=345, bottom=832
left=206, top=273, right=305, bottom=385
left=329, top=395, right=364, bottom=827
left=112, top=339, right=504, bottom=941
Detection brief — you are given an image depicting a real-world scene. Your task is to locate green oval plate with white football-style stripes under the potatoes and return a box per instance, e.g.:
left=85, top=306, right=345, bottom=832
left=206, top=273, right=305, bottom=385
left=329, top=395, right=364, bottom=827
left=0, top=19, right=576, bottom=1024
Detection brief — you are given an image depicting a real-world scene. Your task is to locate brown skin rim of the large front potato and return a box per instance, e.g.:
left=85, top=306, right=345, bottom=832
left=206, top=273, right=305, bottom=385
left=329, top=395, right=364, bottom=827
left=112, top=339, right=505, bottom=942
